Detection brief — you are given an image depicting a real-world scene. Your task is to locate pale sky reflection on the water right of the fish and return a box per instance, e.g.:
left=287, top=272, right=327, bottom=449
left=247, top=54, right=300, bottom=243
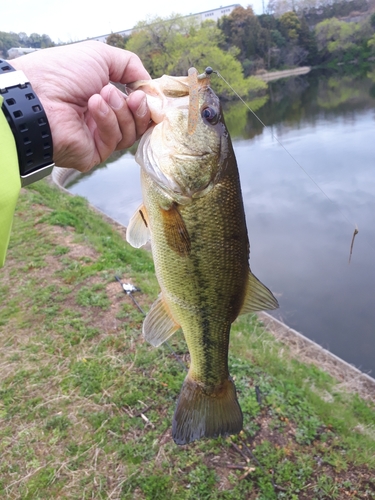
left=236, top=117, right=375, bottom=369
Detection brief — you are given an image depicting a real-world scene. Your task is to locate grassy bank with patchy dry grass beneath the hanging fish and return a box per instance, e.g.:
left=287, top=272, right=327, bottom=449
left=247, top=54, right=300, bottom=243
left=0, top=182, right=375, bottom=500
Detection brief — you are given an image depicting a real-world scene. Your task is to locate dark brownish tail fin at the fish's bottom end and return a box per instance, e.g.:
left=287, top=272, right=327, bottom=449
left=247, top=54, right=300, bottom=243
left=172, top=375, right=243, bottom=444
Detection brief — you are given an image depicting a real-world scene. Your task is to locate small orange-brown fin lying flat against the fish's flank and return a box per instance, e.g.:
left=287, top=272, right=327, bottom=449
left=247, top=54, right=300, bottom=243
left=161, top=203, right=191, bottom=257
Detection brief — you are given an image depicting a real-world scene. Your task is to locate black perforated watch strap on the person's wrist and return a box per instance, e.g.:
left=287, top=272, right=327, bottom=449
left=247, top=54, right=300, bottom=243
left=0, top=59, right=54, bottom=186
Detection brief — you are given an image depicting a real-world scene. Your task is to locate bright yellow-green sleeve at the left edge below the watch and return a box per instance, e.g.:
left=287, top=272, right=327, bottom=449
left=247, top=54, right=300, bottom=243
left=0, top=96, right=21, bottom=267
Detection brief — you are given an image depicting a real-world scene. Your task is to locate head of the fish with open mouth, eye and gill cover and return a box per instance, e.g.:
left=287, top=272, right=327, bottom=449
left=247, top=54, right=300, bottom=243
left=131, top=73, right=231, bottom=204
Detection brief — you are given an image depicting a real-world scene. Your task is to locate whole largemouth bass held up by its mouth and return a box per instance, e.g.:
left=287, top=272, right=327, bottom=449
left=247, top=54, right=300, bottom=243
left=127, top=69, right=278, bottom=445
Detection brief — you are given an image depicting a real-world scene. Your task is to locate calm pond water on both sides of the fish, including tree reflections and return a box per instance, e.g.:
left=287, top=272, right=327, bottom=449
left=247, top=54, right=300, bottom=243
left=69, top=71, right=375, bottom=376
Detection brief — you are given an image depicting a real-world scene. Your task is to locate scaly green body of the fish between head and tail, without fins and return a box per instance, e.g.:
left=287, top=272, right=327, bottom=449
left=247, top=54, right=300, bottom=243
left=142, top=158, right=248, bottom=385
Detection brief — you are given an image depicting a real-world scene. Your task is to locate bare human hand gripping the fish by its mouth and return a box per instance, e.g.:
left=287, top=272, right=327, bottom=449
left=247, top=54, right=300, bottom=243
left=11, top=41, right=150, bottom=172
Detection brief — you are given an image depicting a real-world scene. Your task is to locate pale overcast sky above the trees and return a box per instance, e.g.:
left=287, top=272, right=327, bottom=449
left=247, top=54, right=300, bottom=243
left=0, top=0, right=268, bottom=43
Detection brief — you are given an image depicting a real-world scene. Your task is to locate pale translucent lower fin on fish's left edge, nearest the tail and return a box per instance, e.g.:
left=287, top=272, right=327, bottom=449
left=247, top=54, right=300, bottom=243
left=143, top=294, right=180, bottom=347
